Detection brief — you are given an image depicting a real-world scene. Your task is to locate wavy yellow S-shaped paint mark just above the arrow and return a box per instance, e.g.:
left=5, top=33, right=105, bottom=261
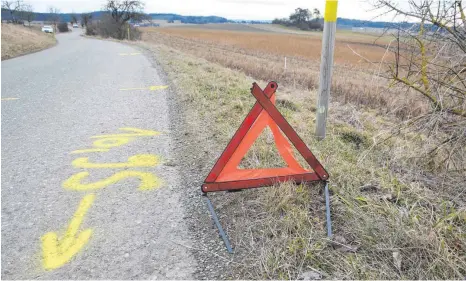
left=63, top=171, right=162, bottom=191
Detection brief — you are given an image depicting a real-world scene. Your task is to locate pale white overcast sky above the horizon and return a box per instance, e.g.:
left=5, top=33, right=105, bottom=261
left=24, top=0, right=396, bottom=20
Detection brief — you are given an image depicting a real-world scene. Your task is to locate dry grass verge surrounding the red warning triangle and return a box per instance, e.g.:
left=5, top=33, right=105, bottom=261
left=136, top=38, right=466, bottom=279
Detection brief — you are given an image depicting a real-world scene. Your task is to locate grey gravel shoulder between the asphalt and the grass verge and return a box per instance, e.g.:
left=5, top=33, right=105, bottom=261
left=137, top=44, right=236, bottom=280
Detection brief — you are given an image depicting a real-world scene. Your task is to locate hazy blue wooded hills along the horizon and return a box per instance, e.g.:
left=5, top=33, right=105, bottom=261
left=2, top=9, right=412, bottom=28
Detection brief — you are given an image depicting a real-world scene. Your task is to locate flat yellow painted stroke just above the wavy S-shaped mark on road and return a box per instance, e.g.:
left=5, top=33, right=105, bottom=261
left=71, top=154, right=160, bottom=168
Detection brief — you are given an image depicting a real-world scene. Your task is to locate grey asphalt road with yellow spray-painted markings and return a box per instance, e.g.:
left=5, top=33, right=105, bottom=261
left=1, top=30, right=196, bottom=279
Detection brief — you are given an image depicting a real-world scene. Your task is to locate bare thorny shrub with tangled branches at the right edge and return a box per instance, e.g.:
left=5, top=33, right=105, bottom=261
left=376, top=0, right=466, bottom=172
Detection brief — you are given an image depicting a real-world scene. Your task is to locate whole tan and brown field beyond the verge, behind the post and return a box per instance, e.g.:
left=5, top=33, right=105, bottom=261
left=142, top=28, right=426, bottom=119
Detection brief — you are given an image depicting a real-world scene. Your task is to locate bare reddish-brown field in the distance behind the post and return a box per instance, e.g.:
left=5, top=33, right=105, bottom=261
left=151, top=27, right=392, bottom=66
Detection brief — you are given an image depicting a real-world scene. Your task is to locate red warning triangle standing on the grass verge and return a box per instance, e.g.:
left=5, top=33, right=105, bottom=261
left=202, top=82, right=328, bottom=192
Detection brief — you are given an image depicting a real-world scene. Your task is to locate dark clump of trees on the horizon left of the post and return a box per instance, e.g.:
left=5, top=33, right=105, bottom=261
left=272, top=8, right=323, bottom=31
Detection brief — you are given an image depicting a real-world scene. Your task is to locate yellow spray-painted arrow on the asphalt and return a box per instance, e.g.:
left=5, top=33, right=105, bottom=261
left=41, top=194, right=95, bottom=270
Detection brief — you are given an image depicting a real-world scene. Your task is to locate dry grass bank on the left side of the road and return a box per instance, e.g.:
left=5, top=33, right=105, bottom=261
left=2, top=24, right=56, bottom=60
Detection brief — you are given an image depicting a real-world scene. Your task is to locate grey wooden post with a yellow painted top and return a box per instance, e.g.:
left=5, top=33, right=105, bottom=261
left=315, top=0, right=338, bottom=140
